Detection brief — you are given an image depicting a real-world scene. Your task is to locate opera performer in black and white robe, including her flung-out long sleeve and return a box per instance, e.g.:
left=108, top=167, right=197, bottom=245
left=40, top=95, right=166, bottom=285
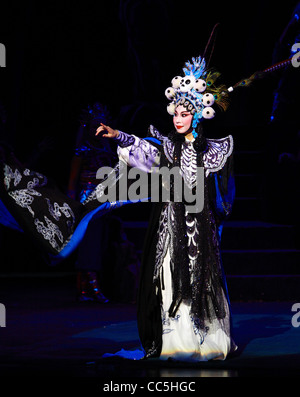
left=0, top=57, right=236, bottom=361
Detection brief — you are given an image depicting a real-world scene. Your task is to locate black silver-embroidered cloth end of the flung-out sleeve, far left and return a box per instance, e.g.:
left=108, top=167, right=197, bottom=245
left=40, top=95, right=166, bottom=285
left=0, top=153, right=84, bottom=255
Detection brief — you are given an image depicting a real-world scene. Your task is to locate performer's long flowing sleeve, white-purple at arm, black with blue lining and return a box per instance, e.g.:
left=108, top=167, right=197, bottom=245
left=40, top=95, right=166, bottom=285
left=0, top=132, right=160, bottom=263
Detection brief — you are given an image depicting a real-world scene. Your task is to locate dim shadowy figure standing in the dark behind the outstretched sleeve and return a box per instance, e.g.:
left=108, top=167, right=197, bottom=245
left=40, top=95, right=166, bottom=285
left=68, top=102, right=116, bottom=303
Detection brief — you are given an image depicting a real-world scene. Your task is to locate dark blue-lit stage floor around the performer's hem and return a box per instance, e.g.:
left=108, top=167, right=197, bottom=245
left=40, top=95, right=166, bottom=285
left=0, top=272, right=300, bottom=379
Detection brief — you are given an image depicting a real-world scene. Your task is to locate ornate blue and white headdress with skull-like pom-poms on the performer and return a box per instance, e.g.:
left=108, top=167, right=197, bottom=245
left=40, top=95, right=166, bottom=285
left=165, top=56, right=228, bottom=138
